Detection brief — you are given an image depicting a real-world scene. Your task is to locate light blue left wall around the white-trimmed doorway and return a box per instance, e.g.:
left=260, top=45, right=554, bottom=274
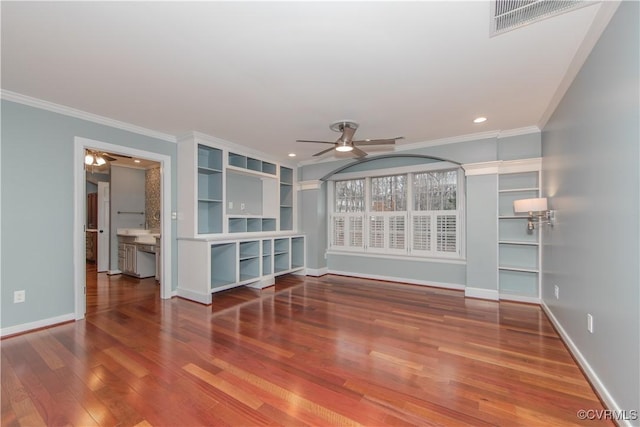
left=0, top=100, right=177, bottom=328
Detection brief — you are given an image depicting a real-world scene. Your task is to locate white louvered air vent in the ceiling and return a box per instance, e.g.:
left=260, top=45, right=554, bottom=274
left=490, top=0, right=595, bottom=36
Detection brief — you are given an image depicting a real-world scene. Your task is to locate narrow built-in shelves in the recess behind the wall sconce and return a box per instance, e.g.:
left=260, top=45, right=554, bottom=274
left=498, top=168, right=540, bottom=301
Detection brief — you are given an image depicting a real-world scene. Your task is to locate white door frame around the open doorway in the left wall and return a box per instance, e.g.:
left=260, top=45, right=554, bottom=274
left=73, top=136, right=173, bottom=320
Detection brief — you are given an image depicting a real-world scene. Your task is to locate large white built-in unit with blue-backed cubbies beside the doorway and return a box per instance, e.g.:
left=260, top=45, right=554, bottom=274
left=177, top=133, right=305, bottom=304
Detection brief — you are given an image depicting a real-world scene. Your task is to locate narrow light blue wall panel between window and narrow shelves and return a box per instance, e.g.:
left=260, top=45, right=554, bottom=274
left=466, top=174, right=498, bottom=291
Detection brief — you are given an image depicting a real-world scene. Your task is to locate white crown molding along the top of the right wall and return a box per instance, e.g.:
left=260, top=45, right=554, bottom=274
left=538, top=0, right=621, bottom=129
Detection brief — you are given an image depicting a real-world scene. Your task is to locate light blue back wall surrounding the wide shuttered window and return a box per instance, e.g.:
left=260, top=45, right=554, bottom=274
left=298, top=133, right=540, bottom=290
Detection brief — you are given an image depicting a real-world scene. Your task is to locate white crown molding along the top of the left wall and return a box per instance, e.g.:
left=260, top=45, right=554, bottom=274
left=0, top=89, right=176, bottom=143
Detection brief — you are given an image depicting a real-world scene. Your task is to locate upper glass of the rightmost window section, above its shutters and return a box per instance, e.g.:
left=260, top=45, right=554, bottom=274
left=413, top=169, right=458, bottom=211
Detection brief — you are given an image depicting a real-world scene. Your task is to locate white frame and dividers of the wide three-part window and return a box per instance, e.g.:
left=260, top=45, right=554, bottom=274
left=327, top=162, right=465, bottom=261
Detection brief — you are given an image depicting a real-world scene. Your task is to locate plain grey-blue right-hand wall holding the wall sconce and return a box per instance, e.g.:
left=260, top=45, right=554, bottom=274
left=542, top=1, right=640, bottom=411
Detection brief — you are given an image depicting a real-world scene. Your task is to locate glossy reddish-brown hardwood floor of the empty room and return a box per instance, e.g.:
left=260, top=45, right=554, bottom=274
left=1, top=275, right=612, bottom=426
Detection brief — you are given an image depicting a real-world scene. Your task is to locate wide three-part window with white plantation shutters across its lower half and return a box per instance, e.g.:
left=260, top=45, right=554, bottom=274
left=331, top=168, right=463, bottom=258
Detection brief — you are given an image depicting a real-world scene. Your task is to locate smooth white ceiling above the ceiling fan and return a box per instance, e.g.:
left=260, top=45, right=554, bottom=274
left=1, top=1, right=603, bottom=160
